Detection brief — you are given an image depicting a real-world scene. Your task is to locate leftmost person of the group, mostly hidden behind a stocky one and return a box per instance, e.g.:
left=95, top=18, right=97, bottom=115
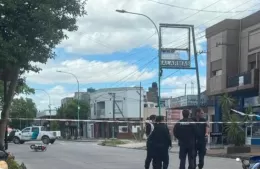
left=144, top=115, right=156, bottom=169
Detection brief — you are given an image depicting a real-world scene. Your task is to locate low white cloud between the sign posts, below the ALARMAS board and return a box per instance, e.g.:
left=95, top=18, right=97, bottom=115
left=161, top=75, right=206, bottom=97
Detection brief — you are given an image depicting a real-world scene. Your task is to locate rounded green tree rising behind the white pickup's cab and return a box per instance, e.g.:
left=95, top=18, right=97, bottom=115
left=10, top=97, right=37, bottom=129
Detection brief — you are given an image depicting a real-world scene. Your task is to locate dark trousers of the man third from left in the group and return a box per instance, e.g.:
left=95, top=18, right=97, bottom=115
left=179, top=146, right=195, bottom=169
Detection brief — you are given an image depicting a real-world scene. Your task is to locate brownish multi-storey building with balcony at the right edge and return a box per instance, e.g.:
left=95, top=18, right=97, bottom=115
left=206, top=11, right=260, bottom=142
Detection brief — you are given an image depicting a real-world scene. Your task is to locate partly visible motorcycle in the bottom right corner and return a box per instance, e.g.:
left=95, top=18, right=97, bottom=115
left=236, top=156, right=260, bottom=169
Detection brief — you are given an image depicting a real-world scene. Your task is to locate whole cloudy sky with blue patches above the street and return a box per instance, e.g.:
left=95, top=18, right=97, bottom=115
left=18, top=0, right=260, bottom=110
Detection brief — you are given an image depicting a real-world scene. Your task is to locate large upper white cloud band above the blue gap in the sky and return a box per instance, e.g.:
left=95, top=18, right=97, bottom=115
left=57, top=0, right=258, bottom=54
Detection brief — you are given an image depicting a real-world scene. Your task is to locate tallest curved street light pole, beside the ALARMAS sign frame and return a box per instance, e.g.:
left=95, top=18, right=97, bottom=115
left=116, top=9, right=162, bottom=115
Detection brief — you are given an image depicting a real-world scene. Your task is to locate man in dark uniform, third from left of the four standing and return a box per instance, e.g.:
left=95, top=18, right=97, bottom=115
left=173, top=110, right=197, bottom=169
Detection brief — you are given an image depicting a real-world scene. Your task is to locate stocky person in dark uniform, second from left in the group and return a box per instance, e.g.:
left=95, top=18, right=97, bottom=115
left=149, top=116, right=172, bottom=169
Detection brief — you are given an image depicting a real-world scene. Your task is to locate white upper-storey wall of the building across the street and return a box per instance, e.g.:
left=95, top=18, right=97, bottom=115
left=90, top=87, right=144, bottom=119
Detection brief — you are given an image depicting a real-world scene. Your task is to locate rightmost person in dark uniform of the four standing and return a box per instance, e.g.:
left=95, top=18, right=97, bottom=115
left=192, top=108, right=209, bottom=169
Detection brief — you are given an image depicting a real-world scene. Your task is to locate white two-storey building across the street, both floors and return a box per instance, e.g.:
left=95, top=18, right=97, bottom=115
left=88, top=87, right=145, bottom=138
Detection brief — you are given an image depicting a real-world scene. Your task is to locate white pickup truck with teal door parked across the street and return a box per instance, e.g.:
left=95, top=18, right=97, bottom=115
left=13, top=126, right=56, bottom=144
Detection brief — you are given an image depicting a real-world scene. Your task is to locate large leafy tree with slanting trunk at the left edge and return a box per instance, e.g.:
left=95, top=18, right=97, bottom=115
left=0, top=0, right=86, bottom=149
